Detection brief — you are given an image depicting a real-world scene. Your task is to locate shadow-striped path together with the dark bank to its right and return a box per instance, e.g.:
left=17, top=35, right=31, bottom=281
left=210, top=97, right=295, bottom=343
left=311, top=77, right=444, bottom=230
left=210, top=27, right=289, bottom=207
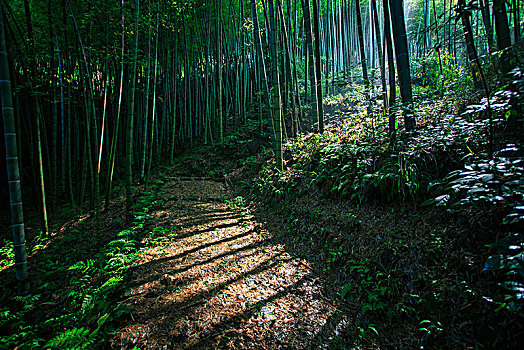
left=107, top=110, right=522, bottom=349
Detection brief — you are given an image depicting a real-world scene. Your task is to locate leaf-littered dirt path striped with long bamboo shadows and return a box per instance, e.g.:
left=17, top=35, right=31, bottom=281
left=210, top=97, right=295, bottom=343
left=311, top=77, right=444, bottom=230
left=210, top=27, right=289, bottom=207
left=112, top=179, right=351, bottom=350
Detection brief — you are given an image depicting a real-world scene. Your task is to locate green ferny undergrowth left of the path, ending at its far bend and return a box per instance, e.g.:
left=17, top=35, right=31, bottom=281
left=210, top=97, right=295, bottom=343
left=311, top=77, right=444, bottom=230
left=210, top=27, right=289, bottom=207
left=0, top=181, right=165, bottom=349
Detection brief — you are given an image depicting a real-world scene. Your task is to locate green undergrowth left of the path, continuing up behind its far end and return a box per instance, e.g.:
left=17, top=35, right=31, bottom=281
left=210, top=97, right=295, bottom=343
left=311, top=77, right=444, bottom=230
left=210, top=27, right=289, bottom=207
left=0, top=116, right=270, bottom=350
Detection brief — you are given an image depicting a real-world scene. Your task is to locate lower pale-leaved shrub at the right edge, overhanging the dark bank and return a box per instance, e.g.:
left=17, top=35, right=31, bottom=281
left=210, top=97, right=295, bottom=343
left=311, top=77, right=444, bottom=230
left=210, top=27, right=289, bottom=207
left=424, top=144, right=524, bottom=312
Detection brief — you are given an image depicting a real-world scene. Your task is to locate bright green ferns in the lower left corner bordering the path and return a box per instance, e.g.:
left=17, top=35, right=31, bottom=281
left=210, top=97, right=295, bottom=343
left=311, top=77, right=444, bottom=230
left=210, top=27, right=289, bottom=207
left=0, top=208, right=144, bottom=349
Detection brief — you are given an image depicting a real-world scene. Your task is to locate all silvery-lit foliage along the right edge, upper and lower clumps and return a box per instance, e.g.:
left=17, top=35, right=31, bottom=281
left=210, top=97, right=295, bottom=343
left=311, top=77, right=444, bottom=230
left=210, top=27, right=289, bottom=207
left=424, top=68, right=524, bottom=317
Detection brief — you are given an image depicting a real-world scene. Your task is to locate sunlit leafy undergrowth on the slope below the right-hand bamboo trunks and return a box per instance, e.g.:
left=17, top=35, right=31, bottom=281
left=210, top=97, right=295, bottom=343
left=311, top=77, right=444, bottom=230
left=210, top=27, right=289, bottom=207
left=252, top=104, right=486, bottom=204
